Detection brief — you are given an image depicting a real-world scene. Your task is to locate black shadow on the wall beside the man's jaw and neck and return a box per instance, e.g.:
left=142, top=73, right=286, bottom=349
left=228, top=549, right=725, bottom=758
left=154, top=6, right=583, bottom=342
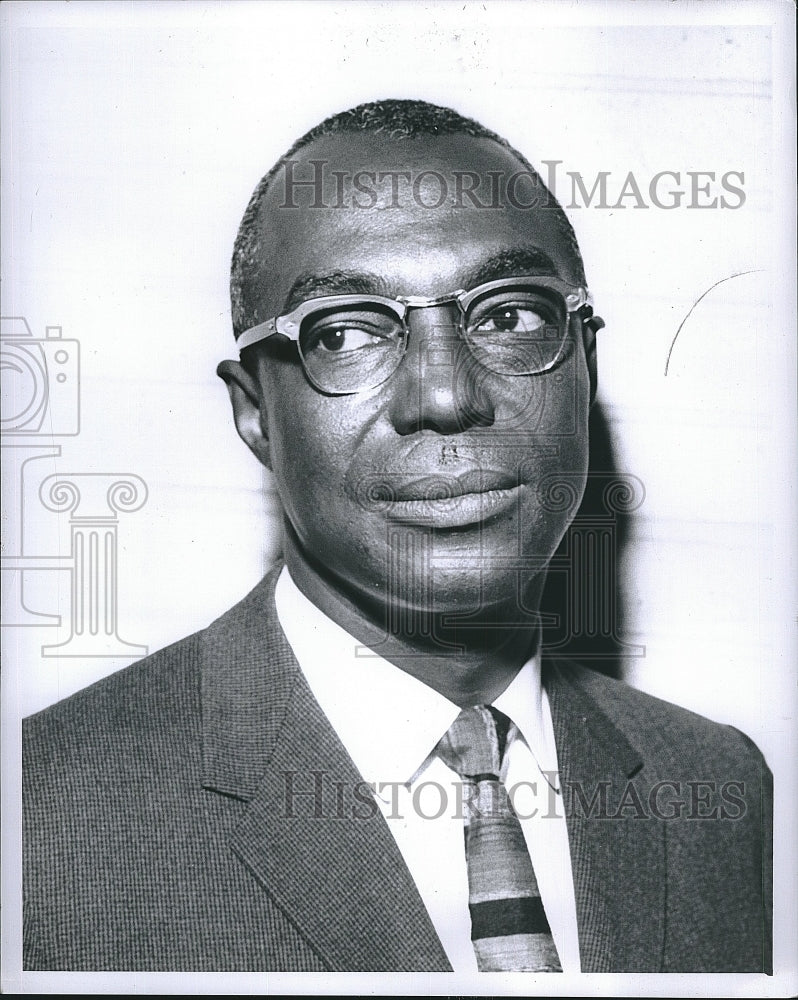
left=541, top=402, right=645, bottom=679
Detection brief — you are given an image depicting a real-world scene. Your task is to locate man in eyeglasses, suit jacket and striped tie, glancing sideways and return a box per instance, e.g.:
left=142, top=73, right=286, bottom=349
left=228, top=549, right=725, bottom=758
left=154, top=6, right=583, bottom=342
left=24, top=101, right=770, bottom=972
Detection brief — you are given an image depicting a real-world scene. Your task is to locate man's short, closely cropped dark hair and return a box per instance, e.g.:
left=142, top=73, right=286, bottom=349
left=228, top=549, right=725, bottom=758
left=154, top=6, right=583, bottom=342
left=230, top=99, right=584, bottom=337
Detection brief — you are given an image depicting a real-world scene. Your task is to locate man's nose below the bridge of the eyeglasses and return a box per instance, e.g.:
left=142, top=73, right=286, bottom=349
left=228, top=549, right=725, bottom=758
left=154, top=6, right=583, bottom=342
left=389, top=305, right=495, bottom=434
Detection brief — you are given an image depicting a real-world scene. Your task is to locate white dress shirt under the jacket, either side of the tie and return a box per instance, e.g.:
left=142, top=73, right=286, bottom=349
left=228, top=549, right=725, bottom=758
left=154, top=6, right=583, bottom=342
left=275, top=567, right=580, bottom=973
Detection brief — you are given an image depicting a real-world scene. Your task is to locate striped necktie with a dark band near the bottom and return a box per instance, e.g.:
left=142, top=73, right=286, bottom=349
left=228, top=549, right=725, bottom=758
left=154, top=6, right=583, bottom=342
left=436, top=706, right=562, bottom=972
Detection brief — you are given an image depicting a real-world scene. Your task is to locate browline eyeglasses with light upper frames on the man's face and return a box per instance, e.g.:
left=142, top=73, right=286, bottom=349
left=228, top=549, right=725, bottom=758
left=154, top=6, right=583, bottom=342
left=238, top=277, right=604, bottom=396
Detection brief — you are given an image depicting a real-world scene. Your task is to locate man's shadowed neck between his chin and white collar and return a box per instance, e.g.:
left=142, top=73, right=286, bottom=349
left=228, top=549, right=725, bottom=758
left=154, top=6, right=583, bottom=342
left=283, top=523, right=545, bottom=708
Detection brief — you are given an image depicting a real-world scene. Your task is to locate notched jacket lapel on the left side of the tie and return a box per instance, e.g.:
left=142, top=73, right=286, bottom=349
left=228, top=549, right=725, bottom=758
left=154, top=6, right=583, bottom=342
left=203, top=571, right=451, bottom=972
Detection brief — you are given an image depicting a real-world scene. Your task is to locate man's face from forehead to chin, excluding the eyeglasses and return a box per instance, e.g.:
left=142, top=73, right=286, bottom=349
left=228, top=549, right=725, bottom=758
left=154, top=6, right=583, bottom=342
left=231, top=135, right=590, bottom=613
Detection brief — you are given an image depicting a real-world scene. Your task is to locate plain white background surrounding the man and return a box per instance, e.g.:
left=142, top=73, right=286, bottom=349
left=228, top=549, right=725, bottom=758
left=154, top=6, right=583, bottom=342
left=2, top=2, right=796, bottom=992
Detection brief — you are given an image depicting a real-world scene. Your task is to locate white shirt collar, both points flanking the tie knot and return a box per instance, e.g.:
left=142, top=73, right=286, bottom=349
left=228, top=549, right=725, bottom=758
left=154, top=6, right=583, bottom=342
left=274, top=566, right=556, bottom=783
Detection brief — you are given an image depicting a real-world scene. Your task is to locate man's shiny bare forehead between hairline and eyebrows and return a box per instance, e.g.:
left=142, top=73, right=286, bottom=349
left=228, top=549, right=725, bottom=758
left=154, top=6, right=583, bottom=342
left=253, top=134, right=577, bottom=315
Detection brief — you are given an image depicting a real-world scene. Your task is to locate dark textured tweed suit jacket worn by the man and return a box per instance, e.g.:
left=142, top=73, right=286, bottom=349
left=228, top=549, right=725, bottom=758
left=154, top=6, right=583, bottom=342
left=23, top=571, right=770, bottom=972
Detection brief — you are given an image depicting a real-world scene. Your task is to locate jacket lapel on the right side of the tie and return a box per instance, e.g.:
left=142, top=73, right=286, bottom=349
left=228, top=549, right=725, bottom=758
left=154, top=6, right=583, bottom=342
left=544, top=661, right=666, bottom=972
